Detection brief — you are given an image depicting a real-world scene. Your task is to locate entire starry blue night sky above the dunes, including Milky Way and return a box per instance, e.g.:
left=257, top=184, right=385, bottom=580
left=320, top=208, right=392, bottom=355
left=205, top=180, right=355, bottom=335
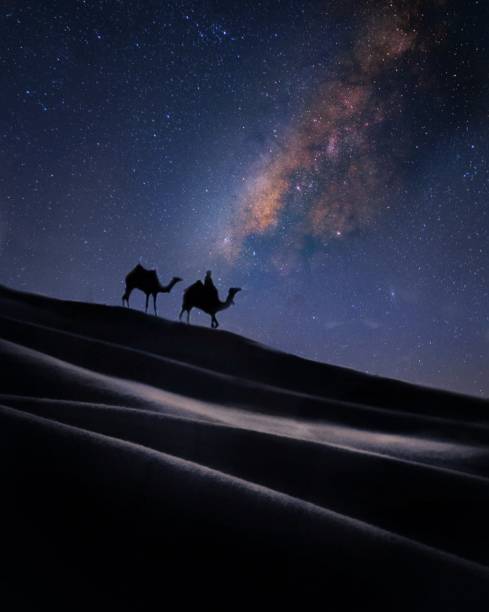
left=0, top=0, right=489, bottom=397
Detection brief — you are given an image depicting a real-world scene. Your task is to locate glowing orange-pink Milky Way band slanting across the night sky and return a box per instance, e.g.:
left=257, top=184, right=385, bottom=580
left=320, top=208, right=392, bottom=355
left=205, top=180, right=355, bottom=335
left=221, top=2, right=443, bottom=260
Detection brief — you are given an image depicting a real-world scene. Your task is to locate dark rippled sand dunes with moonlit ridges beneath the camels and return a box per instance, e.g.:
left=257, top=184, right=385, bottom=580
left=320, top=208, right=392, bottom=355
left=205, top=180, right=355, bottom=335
left=0, top=287, right=489, bottom=611
